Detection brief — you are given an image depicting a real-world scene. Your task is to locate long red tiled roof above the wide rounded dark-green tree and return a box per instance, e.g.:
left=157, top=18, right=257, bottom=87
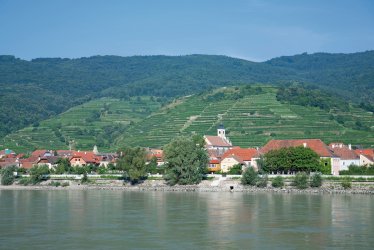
left=261, top=139, right=333, bottom=157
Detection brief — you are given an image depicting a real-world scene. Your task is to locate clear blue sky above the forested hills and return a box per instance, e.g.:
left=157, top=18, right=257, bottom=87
left=0, top=0, right=374, bottom=62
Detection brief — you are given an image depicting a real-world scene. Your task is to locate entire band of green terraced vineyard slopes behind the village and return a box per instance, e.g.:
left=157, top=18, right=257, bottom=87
left=0, top=85, right=374, bottom=152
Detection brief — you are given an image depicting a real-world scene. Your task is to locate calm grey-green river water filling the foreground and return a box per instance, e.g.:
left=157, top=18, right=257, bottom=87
left=0, top=190, right=374, bottom=249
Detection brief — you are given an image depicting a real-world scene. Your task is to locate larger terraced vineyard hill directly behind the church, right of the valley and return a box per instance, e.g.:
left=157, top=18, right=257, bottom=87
left=116, top=87, right=374, bottom=147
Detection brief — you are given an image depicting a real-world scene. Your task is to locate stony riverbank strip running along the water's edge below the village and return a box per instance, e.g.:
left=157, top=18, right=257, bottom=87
left=0, top=180, right=374, bottom=195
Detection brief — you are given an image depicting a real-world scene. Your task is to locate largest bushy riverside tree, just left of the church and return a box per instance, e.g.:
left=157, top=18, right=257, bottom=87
left=164, top=137, right=208, bottom=185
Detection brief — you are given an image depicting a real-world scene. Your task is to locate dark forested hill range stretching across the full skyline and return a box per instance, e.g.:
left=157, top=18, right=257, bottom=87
left=0, top=51, right=374, bottom=138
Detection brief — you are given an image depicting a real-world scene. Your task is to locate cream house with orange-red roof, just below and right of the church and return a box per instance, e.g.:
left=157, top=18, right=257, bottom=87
left=221, top=147, right=258, bottom=173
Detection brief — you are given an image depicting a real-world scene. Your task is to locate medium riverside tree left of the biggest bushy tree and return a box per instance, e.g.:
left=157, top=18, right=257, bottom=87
left=117, top=147, right=148, bottom=184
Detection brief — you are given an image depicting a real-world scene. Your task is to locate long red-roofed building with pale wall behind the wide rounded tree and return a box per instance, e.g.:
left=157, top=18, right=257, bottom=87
left=260, top=139, right=340, bottom=175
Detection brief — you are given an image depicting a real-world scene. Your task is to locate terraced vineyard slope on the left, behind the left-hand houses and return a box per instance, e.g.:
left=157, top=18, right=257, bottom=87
left=0, top=97, right=161, bottom=152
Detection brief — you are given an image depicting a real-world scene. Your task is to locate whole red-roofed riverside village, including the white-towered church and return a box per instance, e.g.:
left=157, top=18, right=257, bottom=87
left=0, top=125, right=374, bottom=176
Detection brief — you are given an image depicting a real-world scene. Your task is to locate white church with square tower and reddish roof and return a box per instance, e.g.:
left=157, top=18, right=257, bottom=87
left=204, top=125, right=232, bottom=155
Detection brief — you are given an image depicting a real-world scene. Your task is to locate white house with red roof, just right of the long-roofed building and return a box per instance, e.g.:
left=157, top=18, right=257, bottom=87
left=329, top=143, right=360, bottom=171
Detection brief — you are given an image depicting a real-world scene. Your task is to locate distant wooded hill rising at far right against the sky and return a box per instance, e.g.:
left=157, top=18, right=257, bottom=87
left=265, top=51, right=374, bottom=103
